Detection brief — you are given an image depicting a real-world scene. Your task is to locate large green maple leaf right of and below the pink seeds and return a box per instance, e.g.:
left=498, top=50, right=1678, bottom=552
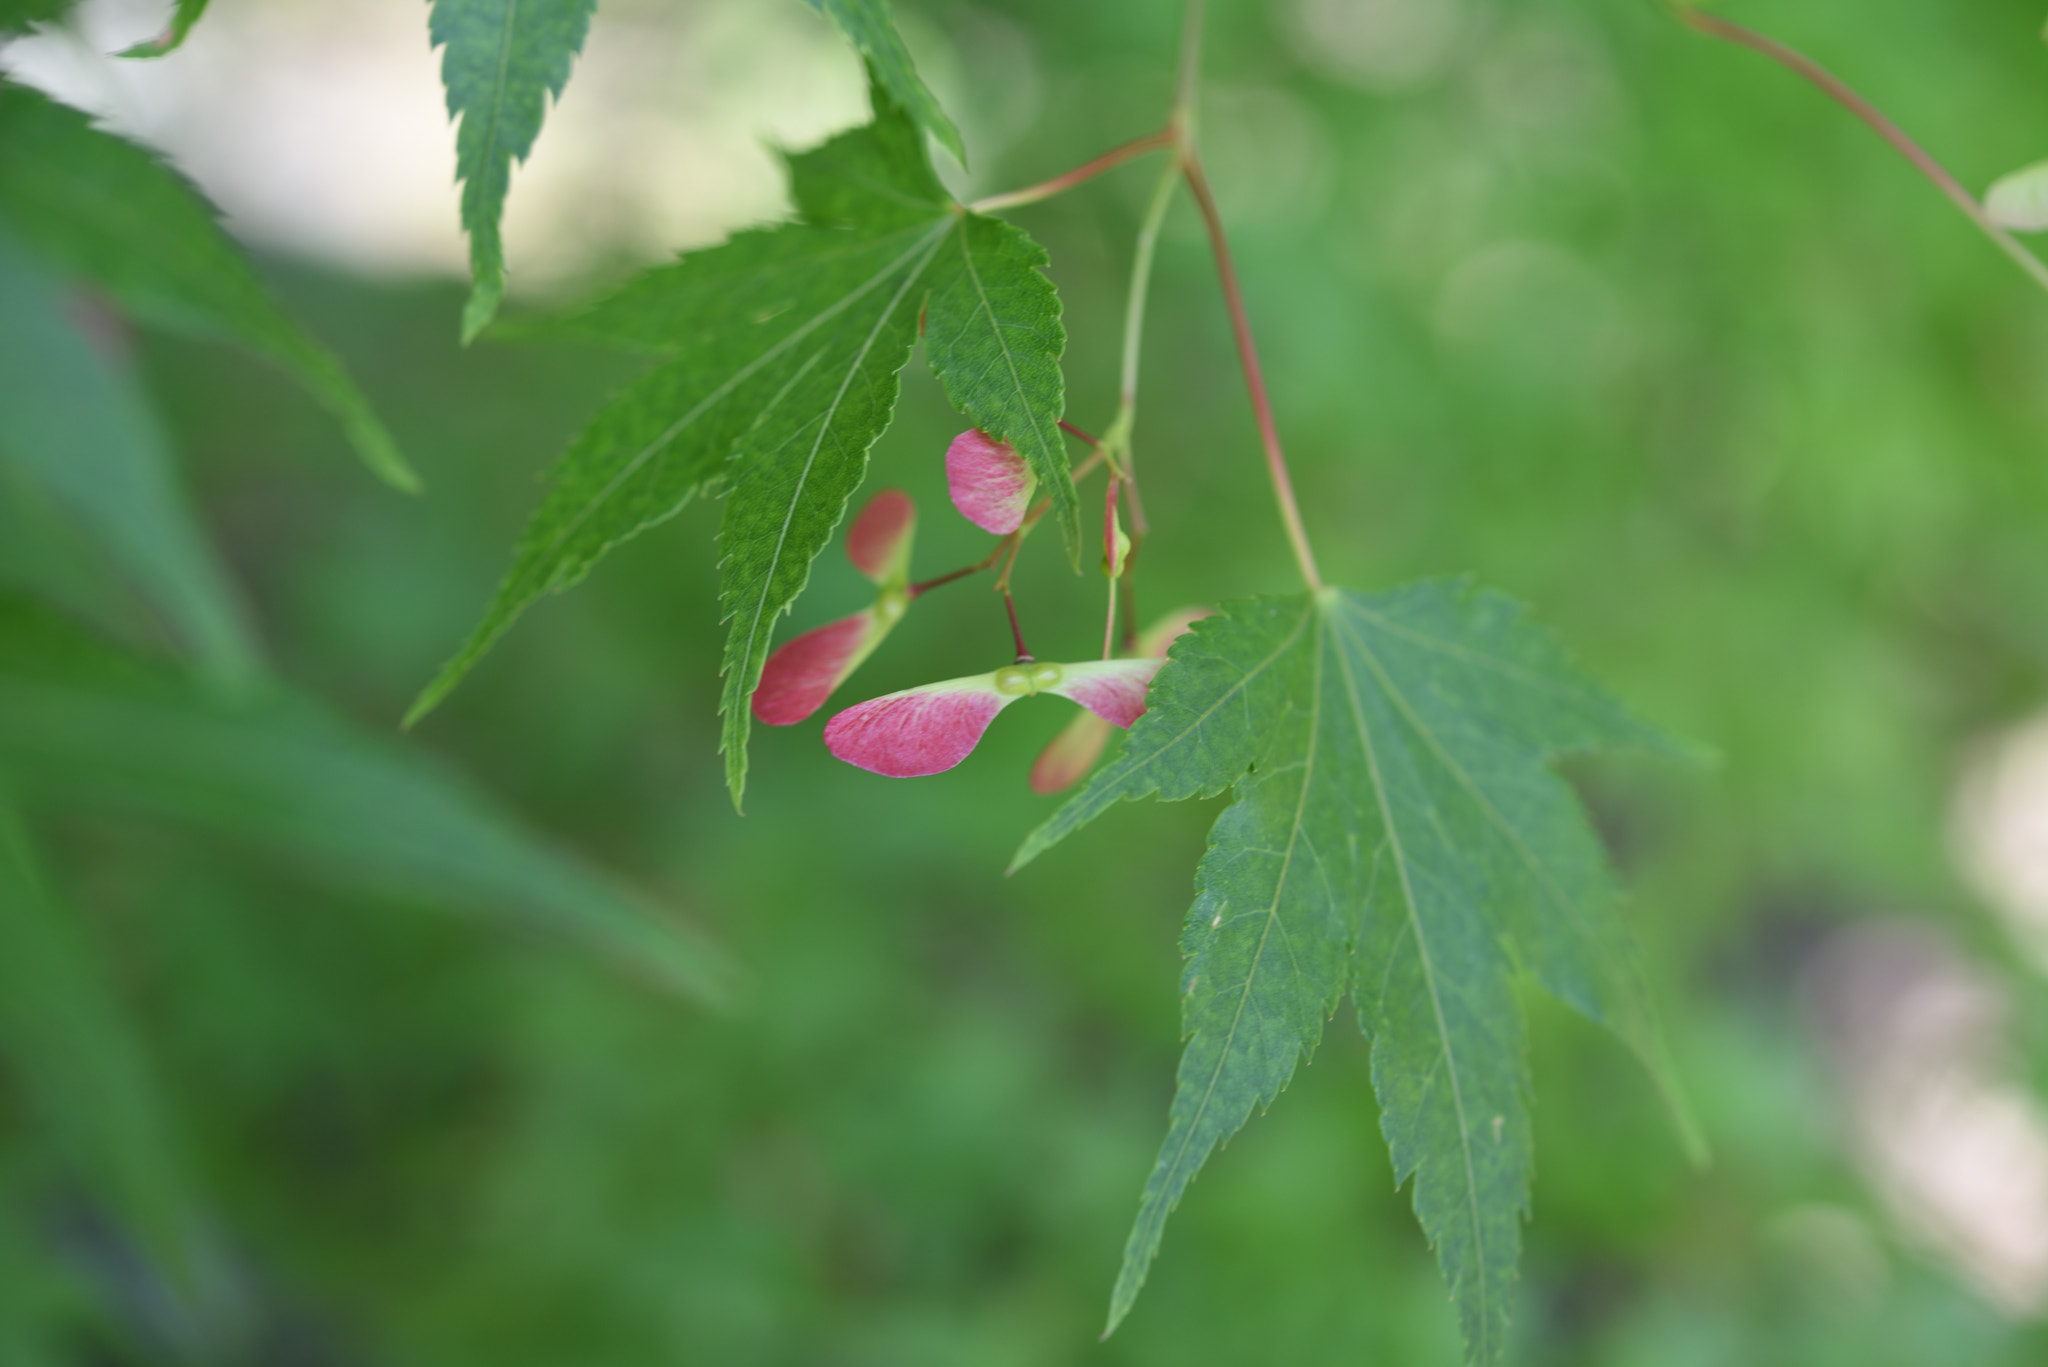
left=1016, top=582, right=1683, bottom=1363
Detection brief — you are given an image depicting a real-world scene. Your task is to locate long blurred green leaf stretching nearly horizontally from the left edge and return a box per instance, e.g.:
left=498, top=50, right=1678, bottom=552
left=0, top=600, right=733, bottom=1002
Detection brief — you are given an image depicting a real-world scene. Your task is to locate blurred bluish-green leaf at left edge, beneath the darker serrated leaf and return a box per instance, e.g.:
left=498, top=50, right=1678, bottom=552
left=0, top=230, right=260, bottom=687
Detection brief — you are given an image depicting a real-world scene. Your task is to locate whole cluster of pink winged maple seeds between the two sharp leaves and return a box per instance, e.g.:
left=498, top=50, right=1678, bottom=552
left=754, top=430, right=1206, bottom=793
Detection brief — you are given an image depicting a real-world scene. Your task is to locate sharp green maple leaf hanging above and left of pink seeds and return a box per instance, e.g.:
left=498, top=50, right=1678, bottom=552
left=408, top=84, right=1079, bottom=801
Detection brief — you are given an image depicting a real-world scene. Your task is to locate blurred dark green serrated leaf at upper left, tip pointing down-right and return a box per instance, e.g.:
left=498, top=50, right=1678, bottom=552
left=0, top=82, right=420, bottom=490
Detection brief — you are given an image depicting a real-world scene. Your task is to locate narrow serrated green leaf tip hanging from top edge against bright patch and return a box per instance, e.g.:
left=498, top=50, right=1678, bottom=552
left=428, top=0, right=598, bottom=342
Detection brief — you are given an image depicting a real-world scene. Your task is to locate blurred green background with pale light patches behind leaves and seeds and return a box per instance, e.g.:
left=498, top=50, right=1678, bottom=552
left=12, top=0, right=2048, bottom=1367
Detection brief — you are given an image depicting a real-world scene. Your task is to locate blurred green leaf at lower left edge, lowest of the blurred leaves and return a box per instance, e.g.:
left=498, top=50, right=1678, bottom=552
left=0, top=793, right=219, bottom=1319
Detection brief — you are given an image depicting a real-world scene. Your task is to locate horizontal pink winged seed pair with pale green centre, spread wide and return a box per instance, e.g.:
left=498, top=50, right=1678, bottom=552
left=825, top=660, right=1165, bottom=779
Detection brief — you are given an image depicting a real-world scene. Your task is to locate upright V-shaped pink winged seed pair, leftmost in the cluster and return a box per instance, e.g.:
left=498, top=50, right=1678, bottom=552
left=754, top=490, right=918, bottom=726
